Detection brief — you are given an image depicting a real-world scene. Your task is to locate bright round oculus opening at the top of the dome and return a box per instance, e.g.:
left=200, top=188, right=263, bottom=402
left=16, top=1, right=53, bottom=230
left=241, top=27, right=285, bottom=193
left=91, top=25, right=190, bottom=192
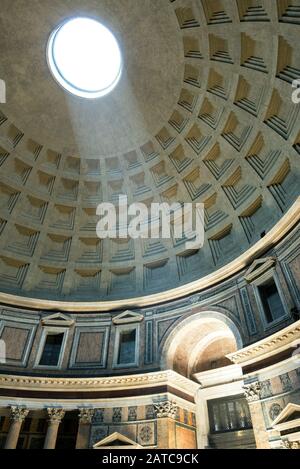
left=47, top=18, right=122, bottom=99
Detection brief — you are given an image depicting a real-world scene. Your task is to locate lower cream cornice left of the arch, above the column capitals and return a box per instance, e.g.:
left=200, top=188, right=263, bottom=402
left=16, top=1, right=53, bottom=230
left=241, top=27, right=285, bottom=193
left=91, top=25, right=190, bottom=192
left=0, top=370, right=199, bottom=397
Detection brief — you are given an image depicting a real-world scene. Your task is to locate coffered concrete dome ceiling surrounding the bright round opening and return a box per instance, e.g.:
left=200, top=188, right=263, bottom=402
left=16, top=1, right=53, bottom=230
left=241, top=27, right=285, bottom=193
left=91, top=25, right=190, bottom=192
left=0, top=0, right=300, bottom=301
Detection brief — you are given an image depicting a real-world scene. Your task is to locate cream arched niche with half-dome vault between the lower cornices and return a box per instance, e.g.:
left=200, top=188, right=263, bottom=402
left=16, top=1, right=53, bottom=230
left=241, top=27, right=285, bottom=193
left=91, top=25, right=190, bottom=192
left=161, top=311, right=243, bottom=378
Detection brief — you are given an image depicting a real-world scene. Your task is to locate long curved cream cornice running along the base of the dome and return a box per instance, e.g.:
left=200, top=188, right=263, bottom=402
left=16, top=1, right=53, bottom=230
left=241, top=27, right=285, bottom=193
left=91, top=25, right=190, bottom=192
left=0, top=197, right=300, bottom=313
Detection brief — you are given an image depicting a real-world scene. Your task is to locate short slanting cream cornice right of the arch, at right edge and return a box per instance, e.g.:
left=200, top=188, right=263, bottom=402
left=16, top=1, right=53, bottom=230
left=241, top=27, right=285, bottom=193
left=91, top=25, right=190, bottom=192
left=226, top=321, right=300, bottom=366
